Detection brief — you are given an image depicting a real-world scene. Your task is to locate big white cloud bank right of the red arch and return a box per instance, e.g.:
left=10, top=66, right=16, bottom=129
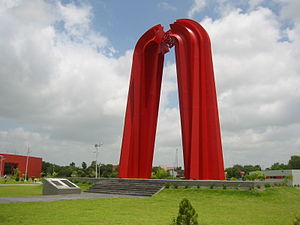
left=202, top=8, right=300, bottom=166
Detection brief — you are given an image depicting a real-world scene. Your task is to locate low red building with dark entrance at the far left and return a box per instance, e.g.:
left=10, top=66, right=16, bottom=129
left=0, top=154, right=42, bottom=177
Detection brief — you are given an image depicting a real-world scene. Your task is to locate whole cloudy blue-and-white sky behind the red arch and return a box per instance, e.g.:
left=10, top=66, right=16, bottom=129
left=0, top=0, right=300, bottom=167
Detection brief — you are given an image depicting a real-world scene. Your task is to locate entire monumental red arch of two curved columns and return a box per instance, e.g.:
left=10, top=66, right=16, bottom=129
left=119, top=19, right=224, bottom=180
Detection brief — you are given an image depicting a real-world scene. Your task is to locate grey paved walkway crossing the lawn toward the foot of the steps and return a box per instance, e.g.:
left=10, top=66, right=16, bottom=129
left=0, top=192, right=145, bottom=204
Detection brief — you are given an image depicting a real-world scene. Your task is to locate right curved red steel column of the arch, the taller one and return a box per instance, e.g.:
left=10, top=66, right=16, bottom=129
left=170, top=19, right=225, bottom=180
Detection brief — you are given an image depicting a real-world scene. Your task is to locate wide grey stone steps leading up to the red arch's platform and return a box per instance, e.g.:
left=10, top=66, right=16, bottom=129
left=86, top=178, right=164, bottom=196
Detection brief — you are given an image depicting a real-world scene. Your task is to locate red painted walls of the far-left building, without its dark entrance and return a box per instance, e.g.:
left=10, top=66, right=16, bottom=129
left=0, top=154, right=42, bottom=177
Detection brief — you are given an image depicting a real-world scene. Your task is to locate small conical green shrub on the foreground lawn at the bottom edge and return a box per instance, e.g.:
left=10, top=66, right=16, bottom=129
left=172, top=198, right=198, bottom=225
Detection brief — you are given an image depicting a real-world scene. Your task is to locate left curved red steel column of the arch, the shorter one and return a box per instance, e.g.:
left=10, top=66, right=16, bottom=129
left=119, top=25, right=168, bottom=178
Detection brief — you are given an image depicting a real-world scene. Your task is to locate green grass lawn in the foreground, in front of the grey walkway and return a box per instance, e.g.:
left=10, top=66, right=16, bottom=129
left=0, top=187, right=300, bottom=225
